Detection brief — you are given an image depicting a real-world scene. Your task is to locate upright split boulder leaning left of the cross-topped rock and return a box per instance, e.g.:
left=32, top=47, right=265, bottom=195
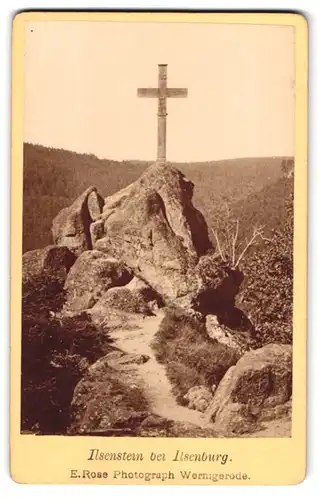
left=52, top=187, right=103, bottom=255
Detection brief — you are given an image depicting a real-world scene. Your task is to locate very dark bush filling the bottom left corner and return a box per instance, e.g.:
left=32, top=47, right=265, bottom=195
left=21, top=274, right=109, bottom=434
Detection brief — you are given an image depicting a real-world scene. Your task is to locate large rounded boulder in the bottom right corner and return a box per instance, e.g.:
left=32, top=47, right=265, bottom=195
left=206, top=344, right=292, bottom=435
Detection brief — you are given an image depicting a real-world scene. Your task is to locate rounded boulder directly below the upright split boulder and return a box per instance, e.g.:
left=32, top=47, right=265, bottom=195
left=64, top=250, right=132, bottom=311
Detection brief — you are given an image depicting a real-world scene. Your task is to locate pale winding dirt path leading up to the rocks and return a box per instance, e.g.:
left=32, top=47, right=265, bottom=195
left=110, top=312, right=212, bottom=428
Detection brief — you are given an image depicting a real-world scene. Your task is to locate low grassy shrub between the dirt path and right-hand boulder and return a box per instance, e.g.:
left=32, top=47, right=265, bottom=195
left=153, top=309, right=239, bottom=401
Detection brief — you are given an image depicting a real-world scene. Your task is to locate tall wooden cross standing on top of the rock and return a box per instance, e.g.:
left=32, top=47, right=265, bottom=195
left=137, top=64, right=187, bottom=164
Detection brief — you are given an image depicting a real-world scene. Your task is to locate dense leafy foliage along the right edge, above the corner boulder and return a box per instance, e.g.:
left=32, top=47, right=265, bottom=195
left=240, top=194, right=293, bottom=346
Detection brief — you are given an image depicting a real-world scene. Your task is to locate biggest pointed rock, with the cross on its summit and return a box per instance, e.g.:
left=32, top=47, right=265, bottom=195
left=90, top=164, right=210, bottom=302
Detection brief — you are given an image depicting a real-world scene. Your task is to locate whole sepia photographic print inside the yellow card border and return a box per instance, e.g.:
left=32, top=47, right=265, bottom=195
left=20, top=20, right=295, bottom=438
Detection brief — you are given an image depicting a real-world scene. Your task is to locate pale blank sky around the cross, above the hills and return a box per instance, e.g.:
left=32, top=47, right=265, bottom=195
left=24, top=21, right=294, bottom=161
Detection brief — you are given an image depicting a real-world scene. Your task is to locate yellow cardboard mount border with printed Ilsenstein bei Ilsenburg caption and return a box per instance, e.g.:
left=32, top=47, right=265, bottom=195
left=10, top=12, right=308, bottom=485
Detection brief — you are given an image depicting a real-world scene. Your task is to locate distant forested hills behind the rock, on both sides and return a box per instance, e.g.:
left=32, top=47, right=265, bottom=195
left=23, top=144, right=292, bottom=252
